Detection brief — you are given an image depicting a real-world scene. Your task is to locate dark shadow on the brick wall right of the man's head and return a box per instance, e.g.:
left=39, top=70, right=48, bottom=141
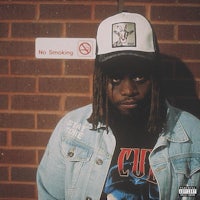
left=161, top=54, right=200, bottom=118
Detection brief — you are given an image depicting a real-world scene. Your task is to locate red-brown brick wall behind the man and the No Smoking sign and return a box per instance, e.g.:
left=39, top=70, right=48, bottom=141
left=0, top=0, right=200, bottom=200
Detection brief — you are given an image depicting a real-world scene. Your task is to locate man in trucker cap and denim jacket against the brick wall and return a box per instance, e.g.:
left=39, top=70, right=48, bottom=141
left=37, top=12, right=200, bottom=200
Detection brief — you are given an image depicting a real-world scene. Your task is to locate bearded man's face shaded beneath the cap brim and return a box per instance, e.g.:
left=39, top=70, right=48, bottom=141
left=107, top=67, right=152, bottom=115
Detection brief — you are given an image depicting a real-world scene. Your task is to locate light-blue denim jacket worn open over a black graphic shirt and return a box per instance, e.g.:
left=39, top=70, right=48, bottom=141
left=37, top=105, right=200, bottom=200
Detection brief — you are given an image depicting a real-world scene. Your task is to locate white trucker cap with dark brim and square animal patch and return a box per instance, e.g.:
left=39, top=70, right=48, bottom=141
left=96, top=12, right=157, bottom=62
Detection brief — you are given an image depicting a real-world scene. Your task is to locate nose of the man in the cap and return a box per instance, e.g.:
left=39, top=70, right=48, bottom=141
left=121, top=78, right=139, bottom=96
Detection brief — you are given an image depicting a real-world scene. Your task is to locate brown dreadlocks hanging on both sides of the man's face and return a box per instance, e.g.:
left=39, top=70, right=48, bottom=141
left=88, top=57, right=167, bottom=134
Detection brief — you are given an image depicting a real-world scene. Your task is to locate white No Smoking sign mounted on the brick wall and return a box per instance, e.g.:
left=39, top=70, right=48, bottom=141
left=35, top=38, right=96, bottom=59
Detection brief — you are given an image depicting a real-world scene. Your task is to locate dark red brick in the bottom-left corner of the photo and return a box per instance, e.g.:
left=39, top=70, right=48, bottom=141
left=0, top=183, right=35, bottom=199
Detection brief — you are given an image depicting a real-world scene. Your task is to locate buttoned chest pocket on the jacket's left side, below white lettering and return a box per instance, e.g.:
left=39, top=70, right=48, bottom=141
left=61, top=140, right=93, bottom=162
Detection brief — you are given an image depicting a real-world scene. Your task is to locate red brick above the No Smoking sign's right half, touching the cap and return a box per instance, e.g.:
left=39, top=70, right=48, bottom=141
left=66, top=23, right=97, bottom=38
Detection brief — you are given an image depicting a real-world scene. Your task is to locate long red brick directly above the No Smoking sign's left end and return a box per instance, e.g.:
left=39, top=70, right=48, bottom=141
left=12, top=23, right=62, bottom=38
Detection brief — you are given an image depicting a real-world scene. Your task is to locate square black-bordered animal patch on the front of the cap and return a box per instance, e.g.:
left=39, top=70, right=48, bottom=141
left=112, top=22, right=136, bottom=48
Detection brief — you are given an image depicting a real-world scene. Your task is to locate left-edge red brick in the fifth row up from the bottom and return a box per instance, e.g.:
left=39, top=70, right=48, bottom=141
left=0, top=113, right=34, bottom=129
